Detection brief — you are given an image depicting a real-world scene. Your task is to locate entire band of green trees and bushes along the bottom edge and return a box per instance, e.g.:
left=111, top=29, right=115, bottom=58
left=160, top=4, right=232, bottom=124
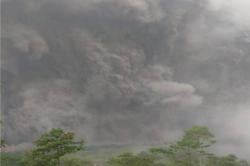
left=1, top=126, right=250, bottom=166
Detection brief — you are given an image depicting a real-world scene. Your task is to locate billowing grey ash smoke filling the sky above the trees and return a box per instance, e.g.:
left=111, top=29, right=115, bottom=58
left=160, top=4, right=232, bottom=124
left=1, top=0, right=250, bottom=156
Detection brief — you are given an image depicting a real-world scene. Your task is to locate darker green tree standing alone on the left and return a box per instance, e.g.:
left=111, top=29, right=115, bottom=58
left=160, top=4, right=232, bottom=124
left=22, top=129, right=84, bottom=166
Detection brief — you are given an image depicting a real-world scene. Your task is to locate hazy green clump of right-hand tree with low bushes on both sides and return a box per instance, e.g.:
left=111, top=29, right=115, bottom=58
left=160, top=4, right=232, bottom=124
left=108, top=126, right=250, bottom=166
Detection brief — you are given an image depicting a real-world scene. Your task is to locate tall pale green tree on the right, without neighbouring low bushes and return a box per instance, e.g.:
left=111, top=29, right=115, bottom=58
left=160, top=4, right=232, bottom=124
left=151, top=126, right=215, bottom=166
